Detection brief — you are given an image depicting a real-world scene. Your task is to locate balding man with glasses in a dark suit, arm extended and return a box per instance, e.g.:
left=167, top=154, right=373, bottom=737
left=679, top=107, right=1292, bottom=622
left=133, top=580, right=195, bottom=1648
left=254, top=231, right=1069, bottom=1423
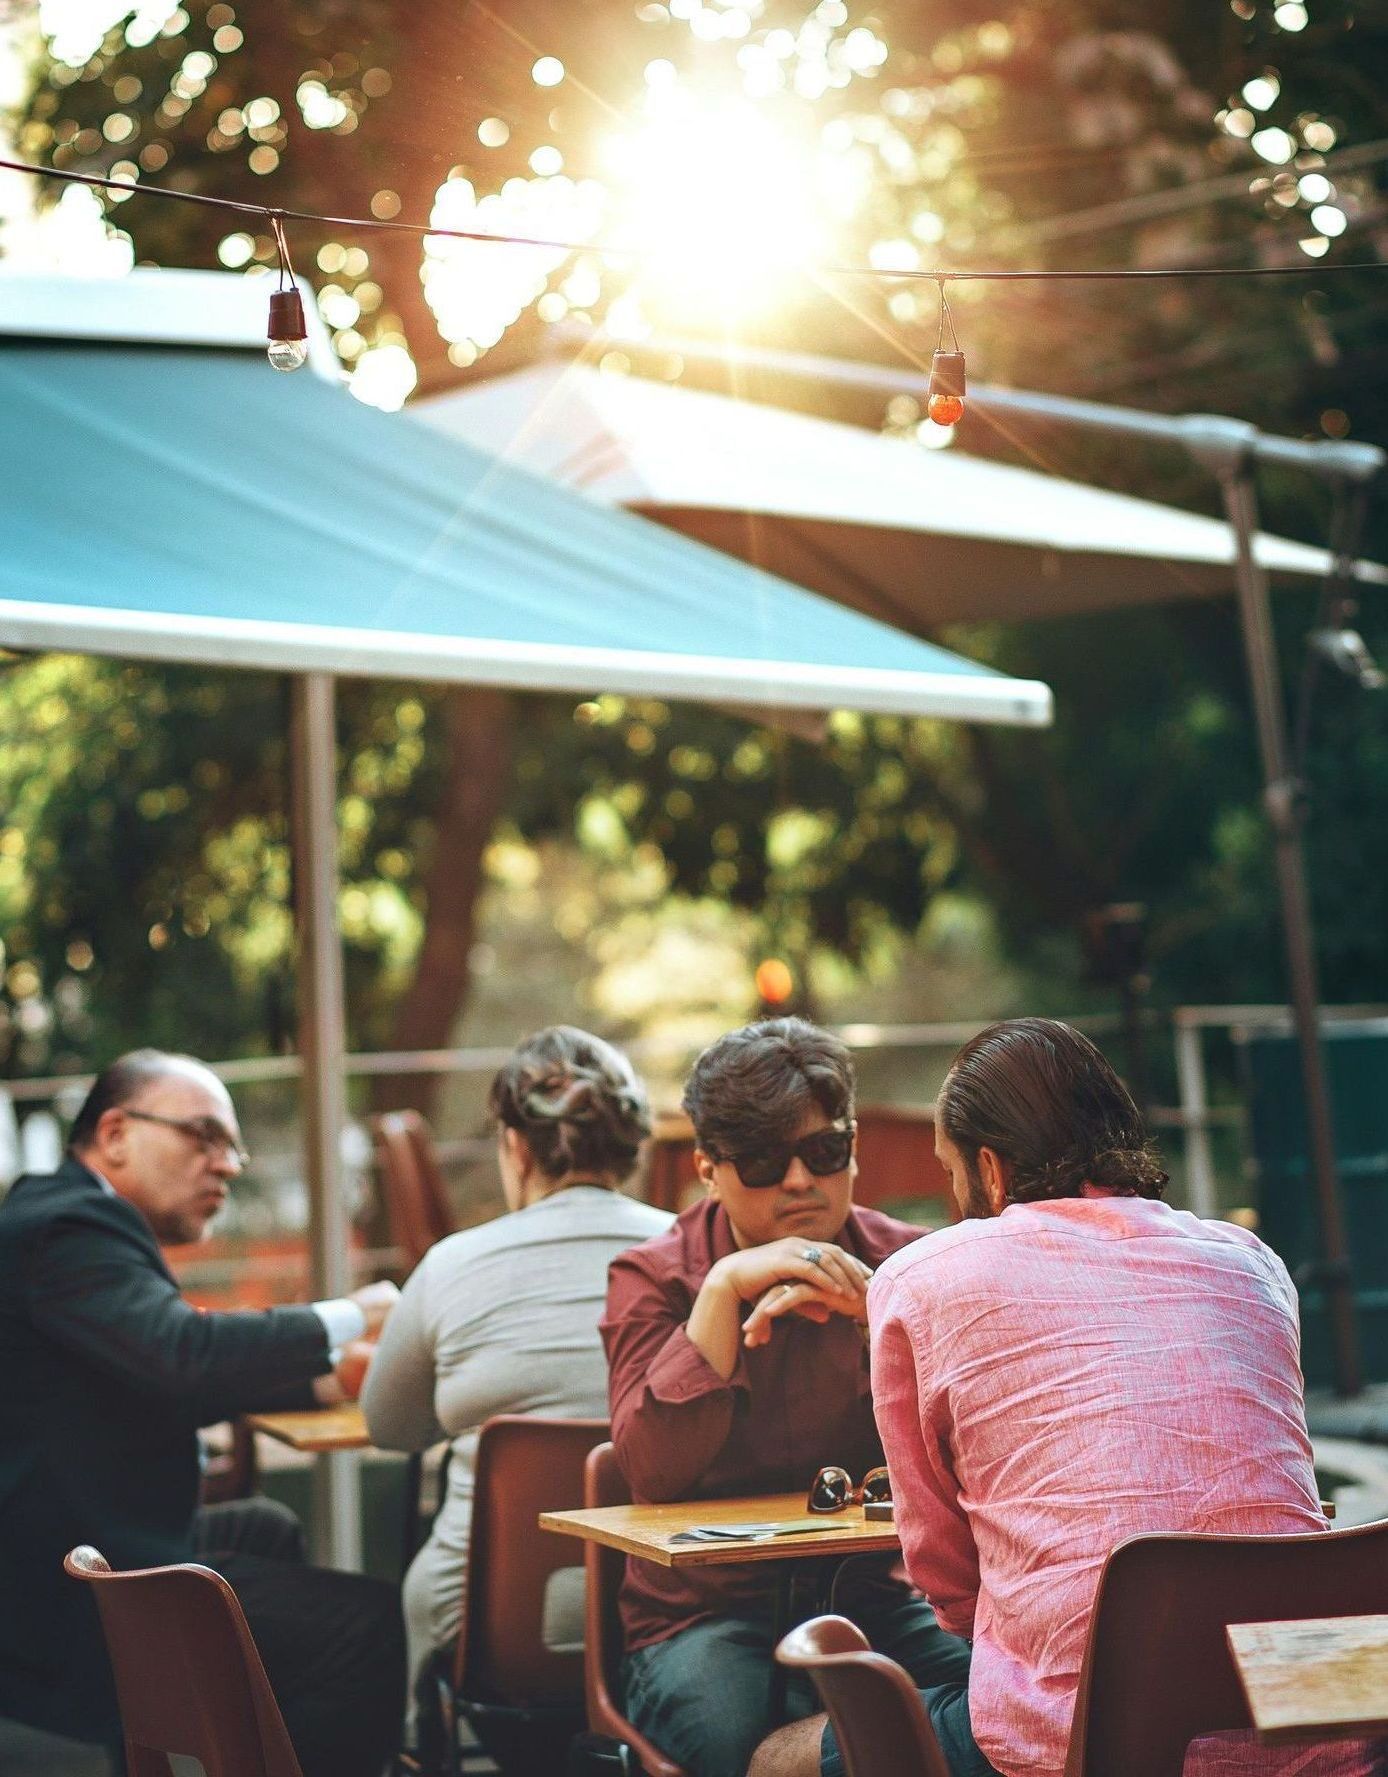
left=0, top=1048, right=403, bottom=1777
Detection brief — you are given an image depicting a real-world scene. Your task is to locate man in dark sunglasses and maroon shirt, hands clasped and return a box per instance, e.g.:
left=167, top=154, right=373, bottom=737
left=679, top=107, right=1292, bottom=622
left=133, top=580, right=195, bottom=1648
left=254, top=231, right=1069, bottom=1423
left=602, top=1018, right=969, bottom=1777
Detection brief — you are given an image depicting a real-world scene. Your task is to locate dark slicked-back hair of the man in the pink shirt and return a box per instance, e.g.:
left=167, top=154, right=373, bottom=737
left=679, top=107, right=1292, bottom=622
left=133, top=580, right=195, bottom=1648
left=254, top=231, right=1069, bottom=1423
left=935, top=1018, right=1168, bottom=1203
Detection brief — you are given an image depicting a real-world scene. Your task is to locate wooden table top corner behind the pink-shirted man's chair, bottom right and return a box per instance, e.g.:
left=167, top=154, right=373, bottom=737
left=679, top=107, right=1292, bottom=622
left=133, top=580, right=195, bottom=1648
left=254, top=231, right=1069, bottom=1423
left=1226, top=1617, right=1388, bottom=1743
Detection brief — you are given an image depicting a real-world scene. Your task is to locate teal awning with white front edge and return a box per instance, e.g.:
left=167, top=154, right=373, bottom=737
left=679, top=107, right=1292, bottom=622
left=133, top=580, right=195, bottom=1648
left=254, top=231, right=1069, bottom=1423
left=0, top=338, right=1050, bottom=725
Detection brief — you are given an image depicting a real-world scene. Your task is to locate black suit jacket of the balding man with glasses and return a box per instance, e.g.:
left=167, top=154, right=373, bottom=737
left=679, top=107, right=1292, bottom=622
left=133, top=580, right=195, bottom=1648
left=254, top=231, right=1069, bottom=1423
left=0, top=1159, right=329, bottom=1740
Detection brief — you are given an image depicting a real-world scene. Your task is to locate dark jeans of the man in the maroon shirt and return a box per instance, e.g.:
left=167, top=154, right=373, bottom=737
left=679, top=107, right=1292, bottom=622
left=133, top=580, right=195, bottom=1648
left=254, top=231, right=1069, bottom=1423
left=624, top=1564, right=974, bottom=1777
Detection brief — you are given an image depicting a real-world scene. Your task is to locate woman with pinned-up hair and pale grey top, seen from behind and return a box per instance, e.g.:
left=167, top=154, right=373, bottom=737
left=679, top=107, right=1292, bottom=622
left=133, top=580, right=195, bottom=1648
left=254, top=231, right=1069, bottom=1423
left=361, top=1025, right=672, bottom=1727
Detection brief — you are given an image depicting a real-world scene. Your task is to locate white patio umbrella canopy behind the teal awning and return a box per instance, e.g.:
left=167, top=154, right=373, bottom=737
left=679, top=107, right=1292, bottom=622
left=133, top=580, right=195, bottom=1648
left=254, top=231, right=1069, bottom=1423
left=419, top=363, right=1388, bottom=629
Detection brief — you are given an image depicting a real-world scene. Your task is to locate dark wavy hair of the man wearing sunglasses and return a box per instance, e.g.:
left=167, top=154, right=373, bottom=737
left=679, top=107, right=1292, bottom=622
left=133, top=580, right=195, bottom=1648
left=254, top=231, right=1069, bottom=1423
left=684, top=1018, right=855, bottom=1159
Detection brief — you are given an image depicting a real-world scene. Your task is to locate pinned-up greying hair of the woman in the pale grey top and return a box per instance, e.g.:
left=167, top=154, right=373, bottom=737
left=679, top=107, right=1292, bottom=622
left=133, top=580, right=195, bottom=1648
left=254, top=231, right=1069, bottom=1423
left=489, top=1024, right=650, bottom=1180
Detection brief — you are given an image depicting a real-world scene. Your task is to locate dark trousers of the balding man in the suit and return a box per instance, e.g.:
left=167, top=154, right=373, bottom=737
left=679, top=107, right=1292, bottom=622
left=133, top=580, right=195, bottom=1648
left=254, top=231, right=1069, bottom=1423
left=194, top=1500, right=405, bottom=1777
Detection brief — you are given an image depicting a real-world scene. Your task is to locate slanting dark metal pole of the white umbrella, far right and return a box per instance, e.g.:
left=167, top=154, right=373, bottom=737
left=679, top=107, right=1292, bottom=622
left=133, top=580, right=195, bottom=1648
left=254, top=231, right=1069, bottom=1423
left=1212, top=453, right=1363, bottom=1395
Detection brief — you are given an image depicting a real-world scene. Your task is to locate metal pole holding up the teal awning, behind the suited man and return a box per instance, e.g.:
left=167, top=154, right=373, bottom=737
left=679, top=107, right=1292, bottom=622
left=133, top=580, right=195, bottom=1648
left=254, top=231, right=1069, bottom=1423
left=290, top=672, right=361, bottom=1571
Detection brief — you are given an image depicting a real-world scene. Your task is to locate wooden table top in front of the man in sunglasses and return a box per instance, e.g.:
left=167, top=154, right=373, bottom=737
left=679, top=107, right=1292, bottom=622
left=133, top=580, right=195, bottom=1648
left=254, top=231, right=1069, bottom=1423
left=540, top=1493, right=901, bottom=1567
